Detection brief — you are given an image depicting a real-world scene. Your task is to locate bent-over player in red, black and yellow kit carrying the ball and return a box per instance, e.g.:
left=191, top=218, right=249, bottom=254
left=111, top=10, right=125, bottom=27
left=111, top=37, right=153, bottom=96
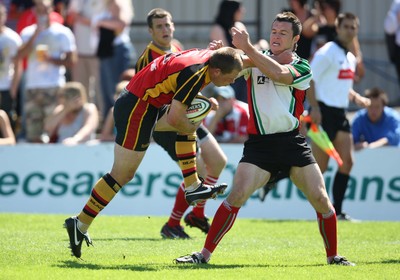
left=64, top=47, right=243, bottom=258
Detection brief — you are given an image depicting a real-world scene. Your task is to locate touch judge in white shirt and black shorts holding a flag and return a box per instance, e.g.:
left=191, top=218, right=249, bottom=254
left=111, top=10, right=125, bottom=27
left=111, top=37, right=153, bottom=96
left=307, top=13, right=370, bottom=221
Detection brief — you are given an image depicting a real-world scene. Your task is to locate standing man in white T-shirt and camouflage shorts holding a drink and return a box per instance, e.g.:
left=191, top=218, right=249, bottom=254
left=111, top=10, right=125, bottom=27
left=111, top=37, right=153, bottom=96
left=18, top=0, right=76, bottom=143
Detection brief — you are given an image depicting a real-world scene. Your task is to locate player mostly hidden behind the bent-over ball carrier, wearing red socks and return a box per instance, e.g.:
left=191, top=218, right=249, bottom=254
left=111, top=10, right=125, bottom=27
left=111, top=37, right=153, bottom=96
left=135, top=8, right=231, bottom=239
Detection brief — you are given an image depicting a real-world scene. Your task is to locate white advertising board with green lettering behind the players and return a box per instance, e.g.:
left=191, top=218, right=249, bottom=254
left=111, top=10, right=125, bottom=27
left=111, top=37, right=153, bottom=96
left=0, top=143, right=400, bottom=221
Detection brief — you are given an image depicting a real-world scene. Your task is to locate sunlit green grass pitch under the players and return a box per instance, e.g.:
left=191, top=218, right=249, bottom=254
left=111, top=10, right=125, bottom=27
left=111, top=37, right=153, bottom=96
left=0, top=213, right=400, bottom=280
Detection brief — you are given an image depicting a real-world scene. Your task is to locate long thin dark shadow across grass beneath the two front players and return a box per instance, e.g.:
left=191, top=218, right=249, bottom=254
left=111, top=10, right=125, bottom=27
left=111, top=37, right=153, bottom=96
left=55, top=260, right=324, bottom=271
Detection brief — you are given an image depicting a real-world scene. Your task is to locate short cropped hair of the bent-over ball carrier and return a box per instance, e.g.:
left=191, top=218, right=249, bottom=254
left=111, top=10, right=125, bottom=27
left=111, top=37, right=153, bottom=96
left=209, top=47, right=243, bottom=74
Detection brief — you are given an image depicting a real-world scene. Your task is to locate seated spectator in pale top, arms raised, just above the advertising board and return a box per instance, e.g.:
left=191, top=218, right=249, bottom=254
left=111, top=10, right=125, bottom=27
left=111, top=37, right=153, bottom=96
left=45, top=82, right=99, bottom=145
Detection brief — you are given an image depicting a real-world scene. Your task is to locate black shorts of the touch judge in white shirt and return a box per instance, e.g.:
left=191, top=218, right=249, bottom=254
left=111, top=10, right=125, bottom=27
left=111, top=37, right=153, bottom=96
left=318, top=102, right=351, bottom=141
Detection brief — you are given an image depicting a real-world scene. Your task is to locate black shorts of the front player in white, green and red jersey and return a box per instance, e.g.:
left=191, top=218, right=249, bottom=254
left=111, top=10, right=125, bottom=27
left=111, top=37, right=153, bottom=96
left=240, top=130, right=316, bottom=178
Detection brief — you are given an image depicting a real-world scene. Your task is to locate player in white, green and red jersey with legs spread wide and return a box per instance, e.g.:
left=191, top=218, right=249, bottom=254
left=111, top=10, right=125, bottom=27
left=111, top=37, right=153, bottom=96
left=175, top=13, right=354, bottom=266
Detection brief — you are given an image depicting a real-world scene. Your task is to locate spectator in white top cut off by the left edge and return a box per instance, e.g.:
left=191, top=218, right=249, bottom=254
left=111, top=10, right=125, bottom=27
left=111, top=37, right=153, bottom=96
left=0, top=3, right=22, bottom=132
